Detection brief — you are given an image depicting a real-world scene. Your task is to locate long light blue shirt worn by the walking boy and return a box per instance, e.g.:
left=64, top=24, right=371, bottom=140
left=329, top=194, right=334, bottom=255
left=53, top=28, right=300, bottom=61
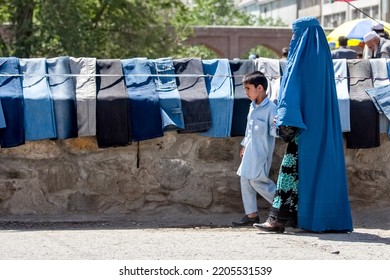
left=237, top=97, right=277, bottom=179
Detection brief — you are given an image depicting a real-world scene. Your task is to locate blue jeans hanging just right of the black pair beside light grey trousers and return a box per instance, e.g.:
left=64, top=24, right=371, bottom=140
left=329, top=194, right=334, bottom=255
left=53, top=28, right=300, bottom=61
left=121, top=58, right=164, bottom=141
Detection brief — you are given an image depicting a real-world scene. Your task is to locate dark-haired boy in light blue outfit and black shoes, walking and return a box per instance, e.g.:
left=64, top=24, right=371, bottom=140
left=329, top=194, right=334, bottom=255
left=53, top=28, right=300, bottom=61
left=233, top=71, right=277, bottom=226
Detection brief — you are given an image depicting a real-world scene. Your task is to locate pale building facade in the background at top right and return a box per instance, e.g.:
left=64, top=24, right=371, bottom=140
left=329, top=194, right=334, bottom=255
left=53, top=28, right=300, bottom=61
left=238, top=0, right=390, bottom=28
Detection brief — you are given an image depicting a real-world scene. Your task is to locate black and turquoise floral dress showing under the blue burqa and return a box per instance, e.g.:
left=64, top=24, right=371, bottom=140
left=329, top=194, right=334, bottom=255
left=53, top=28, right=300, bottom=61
left=268, top=133, right=298, bottom=227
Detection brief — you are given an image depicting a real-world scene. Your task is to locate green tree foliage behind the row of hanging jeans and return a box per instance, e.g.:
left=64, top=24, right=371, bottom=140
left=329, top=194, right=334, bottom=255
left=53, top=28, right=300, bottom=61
left=0, top=0, right=286, bottom=58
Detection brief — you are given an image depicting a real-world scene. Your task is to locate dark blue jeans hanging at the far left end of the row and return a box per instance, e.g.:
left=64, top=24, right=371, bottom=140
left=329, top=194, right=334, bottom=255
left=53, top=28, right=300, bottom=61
left=0, top=57, right=24, bottom=148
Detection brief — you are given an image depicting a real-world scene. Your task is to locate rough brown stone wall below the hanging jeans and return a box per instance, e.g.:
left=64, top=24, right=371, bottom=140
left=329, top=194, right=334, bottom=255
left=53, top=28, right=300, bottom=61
left=0, top=132, right=390, bottom=220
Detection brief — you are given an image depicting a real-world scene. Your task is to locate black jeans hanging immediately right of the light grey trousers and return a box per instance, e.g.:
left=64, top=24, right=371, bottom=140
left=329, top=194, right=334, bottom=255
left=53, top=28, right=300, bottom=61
left=96, top=59, right=132, bottom=148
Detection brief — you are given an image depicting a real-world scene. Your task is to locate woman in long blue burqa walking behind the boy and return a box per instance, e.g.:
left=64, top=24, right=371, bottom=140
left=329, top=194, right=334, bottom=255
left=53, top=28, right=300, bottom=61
left=254, top=17, right=353, bottom=232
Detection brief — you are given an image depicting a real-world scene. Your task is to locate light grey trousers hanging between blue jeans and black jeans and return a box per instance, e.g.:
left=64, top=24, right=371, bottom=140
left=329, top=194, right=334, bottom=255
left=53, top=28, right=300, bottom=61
left=70, top=57, right=96, bottom=137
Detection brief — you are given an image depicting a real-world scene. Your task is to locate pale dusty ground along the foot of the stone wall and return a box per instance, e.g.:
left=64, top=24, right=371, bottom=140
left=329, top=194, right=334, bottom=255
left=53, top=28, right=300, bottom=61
left=0, top=202, right=390, bottom=260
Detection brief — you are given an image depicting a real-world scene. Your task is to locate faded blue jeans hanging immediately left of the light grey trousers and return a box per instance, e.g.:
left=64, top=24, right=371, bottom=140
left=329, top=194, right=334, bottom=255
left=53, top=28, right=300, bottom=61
left=46, top=56, right=78, bottom=139
